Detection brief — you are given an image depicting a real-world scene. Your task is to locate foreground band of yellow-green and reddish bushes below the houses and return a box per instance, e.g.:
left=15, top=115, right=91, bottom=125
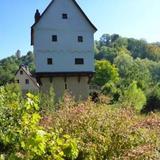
left=0, top=84, right=160, bottom=160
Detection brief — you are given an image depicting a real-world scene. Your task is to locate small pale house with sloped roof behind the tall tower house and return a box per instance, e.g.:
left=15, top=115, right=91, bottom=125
left=15, top=65, right=39, bottom=93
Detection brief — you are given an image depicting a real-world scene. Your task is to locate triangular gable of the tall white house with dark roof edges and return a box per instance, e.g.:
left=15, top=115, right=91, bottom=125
left=31, top=0, right=97, bottom=45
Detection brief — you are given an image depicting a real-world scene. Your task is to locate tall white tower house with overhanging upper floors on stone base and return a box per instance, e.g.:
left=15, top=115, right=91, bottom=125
left=31, top=0, right=97, bottom=98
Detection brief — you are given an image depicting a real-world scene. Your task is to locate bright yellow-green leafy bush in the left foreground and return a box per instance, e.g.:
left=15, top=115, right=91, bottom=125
left=0, top=85, right=78, bottom=160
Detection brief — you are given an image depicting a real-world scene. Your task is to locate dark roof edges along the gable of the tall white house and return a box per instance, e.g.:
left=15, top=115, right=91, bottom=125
left=31, top=0, right=97, bottom=45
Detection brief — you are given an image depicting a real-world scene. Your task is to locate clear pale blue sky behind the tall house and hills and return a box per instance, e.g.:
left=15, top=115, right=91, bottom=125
left=0, top=0, right=160, bottom=59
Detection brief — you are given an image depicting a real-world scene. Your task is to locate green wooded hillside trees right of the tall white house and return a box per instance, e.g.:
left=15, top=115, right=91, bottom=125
left=93, top=34, right=160, bottom=112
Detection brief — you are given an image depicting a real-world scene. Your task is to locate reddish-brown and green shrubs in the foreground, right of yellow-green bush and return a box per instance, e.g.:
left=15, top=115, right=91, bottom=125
left=49, top=94, right=160, bottom=160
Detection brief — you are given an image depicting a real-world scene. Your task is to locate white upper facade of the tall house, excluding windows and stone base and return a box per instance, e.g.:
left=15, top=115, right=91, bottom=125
left=33, top=0, right=96, bottom=73
